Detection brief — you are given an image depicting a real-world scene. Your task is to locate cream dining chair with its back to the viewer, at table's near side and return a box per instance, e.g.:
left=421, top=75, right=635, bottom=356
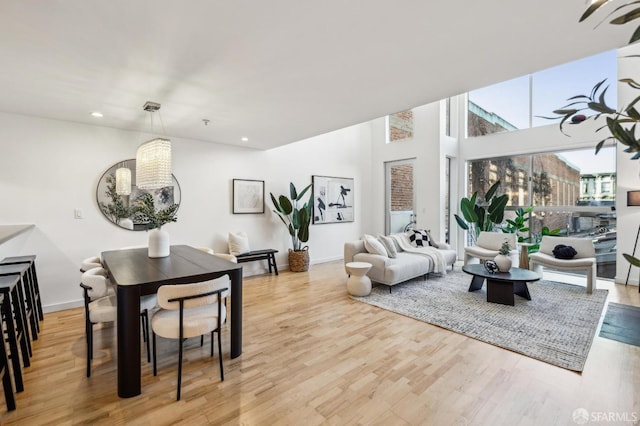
left=151, top=281, right=227, bottom=401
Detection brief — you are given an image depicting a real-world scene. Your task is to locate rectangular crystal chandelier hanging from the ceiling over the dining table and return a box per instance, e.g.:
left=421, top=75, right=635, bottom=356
left=136, top=102, right=173, bottom=189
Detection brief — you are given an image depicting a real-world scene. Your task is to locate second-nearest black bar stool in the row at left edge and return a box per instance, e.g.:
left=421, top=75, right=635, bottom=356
left=0, top=275, right=31, bottom=392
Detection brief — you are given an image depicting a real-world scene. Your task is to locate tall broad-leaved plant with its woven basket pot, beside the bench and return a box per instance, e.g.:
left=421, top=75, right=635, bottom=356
left=269, top=182, right=313, bottom=272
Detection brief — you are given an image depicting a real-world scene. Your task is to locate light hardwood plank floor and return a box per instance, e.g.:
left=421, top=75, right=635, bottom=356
left=0, top=262, right=640, bottom=425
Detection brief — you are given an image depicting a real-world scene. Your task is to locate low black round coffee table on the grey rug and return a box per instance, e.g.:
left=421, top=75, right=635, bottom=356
left=462, top=264, right=540, bottom=306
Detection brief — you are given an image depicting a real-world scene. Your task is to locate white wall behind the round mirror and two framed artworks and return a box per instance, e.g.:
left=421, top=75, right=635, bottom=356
left=0, top=113, right=373, bottom=310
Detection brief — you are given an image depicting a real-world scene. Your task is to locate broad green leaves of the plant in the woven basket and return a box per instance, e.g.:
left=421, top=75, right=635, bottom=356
left=269, top=182, right=313, bottom=251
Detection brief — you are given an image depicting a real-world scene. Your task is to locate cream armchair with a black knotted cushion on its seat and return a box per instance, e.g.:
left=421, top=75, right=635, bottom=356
left=529, top=235, right=597, bottom=294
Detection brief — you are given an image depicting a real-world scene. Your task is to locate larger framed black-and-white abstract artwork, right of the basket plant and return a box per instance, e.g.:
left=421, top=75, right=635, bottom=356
left=312, top=176, right=354, bottom=224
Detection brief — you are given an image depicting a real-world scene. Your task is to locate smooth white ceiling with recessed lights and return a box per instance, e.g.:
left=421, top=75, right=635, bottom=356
left=0, top=0, right=632, bottom=148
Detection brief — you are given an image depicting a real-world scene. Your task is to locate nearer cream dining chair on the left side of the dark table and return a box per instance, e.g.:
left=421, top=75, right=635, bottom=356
left=80, top=268, right=117, bottom=377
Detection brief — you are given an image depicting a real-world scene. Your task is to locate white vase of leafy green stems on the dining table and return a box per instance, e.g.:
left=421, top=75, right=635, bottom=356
left=133, top=193, right=178, bottom=257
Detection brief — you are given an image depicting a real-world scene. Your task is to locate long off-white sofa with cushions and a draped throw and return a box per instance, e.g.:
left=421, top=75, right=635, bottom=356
left=344, top=234, right=457, bottom=291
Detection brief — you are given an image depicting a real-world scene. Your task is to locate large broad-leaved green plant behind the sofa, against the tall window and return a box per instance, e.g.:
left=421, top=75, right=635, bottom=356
left=454, top=181, right=509, bottom=244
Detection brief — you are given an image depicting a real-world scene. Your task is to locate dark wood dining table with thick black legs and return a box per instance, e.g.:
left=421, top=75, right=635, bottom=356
left=102, top=245, right=242, bottom=398
